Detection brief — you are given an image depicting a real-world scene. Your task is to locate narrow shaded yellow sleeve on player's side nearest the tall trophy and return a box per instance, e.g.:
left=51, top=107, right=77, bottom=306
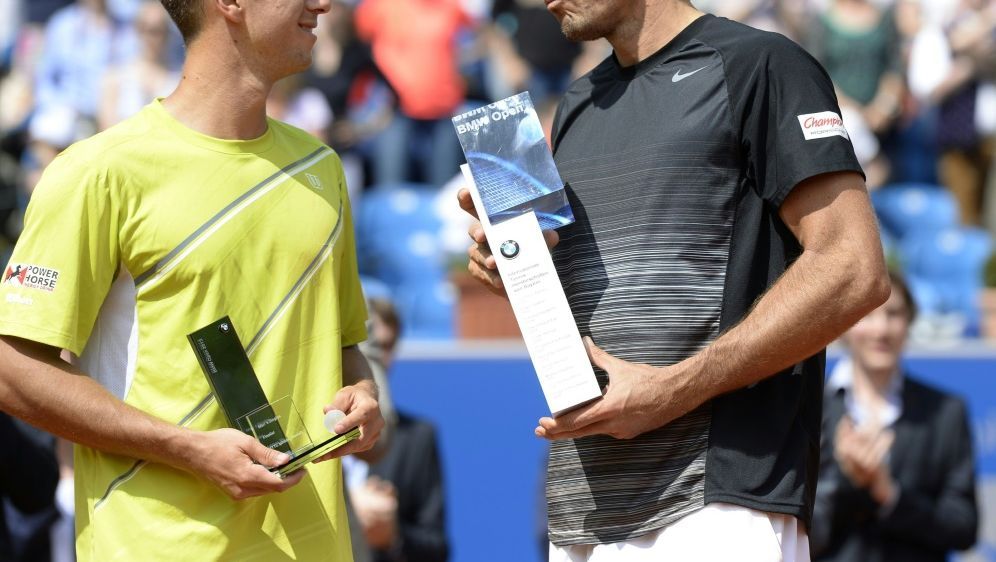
left=337, top=154, right=367, bottom=347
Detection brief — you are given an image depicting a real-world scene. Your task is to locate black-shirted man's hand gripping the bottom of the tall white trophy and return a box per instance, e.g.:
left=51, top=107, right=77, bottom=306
left=536, top=338, right=685, bottom=439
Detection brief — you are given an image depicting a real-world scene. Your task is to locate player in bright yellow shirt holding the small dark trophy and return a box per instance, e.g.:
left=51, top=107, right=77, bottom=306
left=0, top=0, right=383, bottom=562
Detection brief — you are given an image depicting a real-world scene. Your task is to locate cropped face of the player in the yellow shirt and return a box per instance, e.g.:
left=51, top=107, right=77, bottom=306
left=244, top=0, right=331, bottom=80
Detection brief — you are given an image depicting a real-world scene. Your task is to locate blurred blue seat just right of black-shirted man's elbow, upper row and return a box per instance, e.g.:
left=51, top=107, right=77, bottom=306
left=871, top=183, right=958, bottom=240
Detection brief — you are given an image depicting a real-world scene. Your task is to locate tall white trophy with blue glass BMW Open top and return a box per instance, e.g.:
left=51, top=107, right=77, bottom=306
left=453, top=92, right=602, bottom=416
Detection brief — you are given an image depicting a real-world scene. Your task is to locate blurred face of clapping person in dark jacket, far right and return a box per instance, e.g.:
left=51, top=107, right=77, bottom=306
left=844, top=284, right=912, bottom=374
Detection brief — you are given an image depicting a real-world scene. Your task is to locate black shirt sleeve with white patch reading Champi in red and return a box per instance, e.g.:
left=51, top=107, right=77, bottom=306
left=727, top=33, right=864, bottom=208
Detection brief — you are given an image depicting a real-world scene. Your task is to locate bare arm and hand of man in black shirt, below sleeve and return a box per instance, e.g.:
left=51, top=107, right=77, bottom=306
left=536, top=172, right=889, bottom=439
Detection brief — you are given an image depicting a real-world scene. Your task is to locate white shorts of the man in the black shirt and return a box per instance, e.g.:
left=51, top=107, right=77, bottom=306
left=550, top=503, right=809, bottom=562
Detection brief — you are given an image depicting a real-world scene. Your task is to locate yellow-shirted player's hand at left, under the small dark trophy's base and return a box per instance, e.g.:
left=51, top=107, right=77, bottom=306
left=183, top=428, right=306, bottom=500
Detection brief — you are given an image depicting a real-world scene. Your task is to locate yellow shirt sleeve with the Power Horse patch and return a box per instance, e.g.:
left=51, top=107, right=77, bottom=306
left=0, top=149, right=120, bottom=355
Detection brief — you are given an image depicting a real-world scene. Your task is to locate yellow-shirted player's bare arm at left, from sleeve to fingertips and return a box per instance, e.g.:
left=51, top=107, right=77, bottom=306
left=0, top=335, right=305, bottom=499
